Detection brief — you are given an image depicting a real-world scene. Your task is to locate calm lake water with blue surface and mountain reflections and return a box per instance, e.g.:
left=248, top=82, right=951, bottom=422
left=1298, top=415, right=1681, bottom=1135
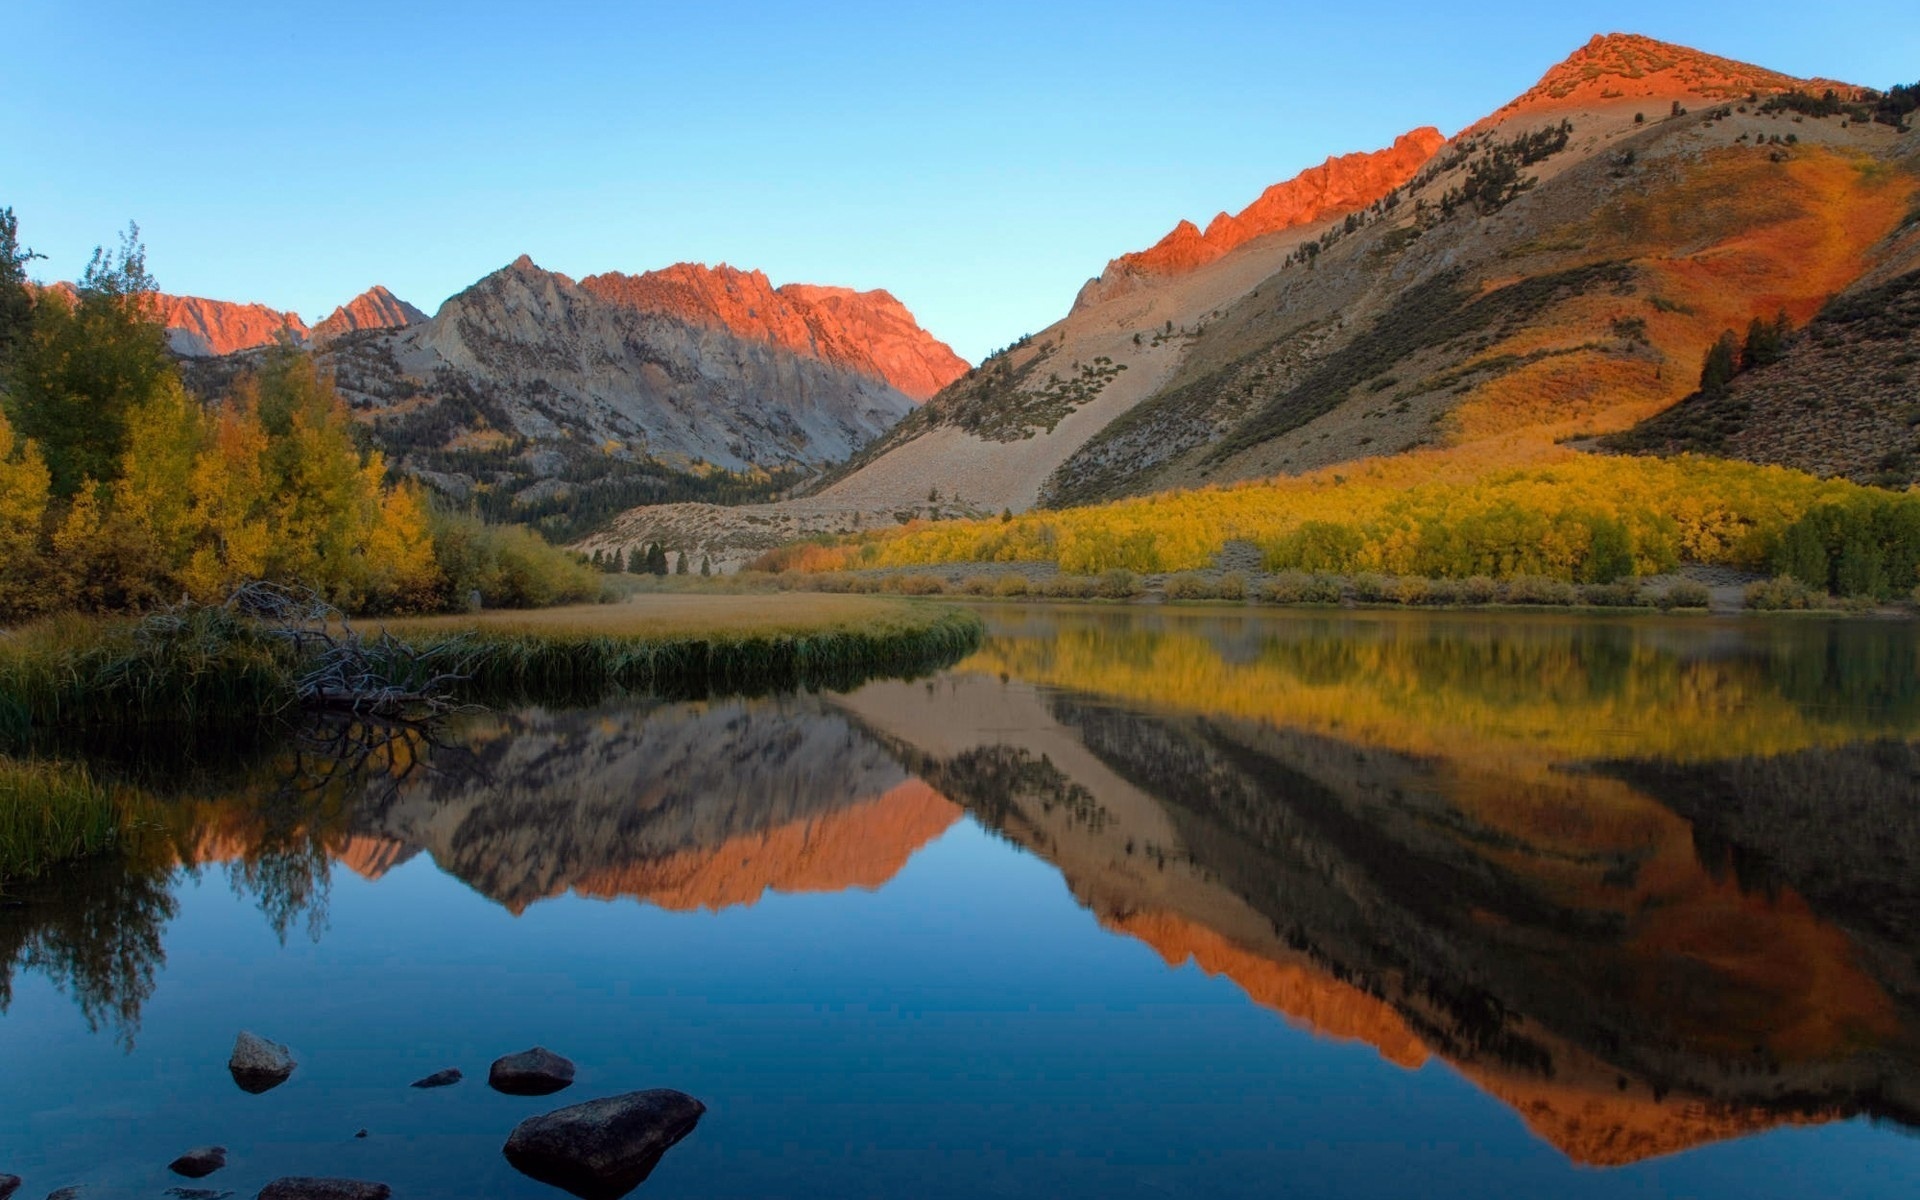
left=0, top=607, right=1920, bottom=1198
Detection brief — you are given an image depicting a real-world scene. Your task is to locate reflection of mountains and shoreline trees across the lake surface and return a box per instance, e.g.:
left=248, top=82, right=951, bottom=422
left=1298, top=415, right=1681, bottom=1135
left=0, top=611, right=1920, bottom=1165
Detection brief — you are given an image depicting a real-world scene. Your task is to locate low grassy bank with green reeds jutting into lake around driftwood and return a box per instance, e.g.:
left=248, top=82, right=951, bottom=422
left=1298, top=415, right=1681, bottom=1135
left=0, top=595, right=981, bottom=745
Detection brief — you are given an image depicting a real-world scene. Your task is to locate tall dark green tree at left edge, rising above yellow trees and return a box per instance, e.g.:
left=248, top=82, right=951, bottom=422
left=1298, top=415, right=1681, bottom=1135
left=10, top=225, right=179, bottom=497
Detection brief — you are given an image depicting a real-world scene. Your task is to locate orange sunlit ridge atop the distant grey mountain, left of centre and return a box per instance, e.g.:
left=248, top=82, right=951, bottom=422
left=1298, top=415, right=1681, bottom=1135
left=580, top=263, right=968, bottom=399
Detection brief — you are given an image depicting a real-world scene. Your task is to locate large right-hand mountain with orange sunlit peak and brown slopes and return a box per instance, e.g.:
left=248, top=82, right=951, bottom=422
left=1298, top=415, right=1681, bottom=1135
left=603, top=35, right=1920, bottom=564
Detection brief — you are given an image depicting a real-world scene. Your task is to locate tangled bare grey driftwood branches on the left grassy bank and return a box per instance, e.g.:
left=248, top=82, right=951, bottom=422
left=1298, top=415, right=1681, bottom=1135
left=225, top=584, right=468, bottom=720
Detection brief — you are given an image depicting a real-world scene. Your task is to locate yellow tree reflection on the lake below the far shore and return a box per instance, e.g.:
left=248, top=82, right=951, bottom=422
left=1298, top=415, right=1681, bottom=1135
left=962, top=622, right=1910, bottom=760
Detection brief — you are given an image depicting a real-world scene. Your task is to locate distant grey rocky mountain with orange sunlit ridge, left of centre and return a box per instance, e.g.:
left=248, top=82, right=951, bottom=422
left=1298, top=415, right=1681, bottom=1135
left=168, top=255, right=968, bottom=540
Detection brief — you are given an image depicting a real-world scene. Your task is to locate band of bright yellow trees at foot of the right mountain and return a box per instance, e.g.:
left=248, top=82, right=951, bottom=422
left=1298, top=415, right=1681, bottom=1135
left=781, top=447, right=1864, bottom=580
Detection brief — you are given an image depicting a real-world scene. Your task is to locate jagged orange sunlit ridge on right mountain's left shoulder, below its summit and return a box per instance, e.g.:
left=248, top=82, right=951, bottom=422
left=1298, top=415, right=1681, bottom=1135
left=1073, top=127, right=1446, bottom=309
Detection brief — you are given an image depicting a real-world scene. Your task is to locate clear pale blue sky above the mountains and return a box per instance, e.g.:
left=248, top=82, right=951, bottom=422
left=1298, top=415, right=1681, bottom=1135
left=0, top=0, right=1920, bottom=359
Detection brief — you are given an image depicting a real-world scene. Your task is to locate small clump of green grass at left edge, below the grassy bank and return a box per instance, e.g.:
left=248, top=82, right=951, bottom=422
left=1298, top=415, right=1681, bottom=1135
left=0, top=758, right=129, bottom=887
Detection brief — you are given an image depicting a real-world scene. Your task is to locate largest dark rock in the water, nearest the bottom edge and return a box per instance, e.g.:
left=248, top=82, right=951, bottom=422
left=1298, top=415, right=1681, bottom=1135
left=507, top=1087, right=707, bottom=1200
